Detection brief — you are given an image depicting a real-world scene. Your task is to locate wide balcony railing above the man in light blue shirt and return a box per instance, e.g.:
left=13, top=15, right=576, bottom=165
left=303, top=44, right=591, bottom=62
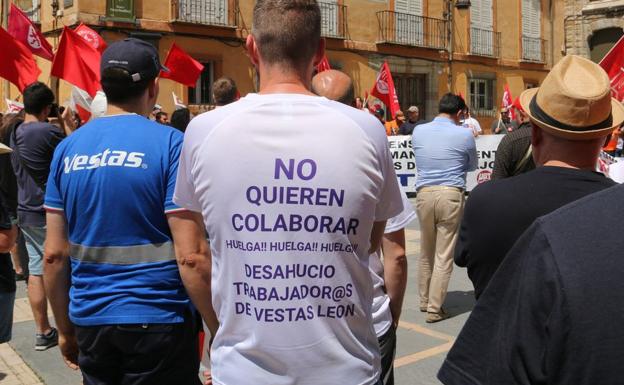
left=377, top=11, right=448, bottom=49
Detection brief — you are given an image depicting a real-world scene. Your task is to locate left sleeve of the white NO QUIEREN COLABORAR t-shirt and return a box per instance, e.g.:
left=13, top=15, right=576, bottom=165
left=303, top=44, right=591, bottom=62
left=173, top=120, right=202, bottom=213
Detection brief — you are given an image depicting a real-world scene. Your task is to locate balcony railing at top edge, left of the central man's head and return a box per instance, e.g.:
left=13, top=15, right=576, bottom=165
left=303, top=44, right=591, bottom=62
left=176, top=0, right=238, bottom=27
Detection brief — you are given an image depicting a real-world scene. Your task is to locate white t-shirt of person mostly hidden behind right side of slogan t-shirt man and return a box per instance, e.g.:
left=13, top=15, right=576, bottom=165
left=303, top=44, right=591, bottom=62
left=369, top=194, right=416, bottom=338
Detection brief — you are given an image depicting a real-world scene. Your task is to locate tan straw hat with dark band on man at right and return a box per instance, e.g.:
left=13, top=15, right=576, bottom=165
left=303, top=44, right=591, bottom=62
left=520, top=55, right=624, bottom=140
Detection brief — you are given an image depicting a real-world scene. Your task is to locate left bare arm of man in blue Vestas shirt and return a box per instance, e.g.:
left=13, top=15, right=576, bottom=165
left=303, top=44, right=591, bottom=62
left=43, top=211, right=78, bottom=370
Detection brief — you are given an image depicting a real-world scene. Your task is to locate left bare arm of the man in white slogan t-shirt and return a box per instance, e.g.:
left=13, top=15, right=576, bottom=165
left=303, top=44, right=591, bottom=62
left=167, top=210, right=219, bottom=336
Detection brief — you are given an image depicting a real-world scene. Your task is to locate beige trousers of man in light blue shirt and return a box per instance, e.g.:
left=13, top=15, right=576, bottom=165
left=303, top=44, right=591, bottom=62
left=416, top=186, right=464, bottom=313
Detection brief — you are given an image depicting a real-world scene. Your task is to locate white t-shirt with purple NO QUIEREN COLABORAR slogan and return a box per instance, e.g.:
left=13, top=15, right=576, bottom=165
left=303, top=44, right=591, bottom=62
left=174, top=94, right=403, bottom=385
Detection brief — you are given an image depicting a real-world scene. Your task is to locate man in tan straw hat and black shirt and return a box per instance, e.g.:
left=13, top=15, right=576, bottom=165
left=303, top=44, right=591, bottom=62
left=455, top=56, right=624, bottom=298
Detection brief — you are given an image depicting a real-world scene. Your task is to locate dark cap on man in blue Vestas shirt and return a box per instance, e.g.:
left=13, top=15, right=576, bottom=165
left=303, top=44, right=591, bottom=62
left=100, top=38, right=169, bottom=82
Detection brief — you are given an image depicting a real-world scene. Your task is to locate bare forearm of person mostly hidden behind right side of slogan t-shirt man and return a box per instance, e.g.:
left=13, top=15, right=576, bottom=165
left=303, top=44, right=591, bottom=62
left=381, top=229, right=407, bottom=326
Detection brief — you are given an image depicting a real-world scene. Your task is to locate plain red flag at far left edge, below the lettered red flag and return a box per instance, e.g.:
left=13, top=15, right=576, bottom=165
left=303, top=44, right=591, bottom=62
left=0, top=28, right=41, bottom=91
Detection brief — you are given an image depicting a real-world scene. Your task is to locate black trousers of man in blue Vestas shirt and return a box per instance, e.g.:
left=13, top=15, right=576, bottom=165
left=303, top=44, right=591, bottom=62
left=76, top=313, right=201, bottom=385
